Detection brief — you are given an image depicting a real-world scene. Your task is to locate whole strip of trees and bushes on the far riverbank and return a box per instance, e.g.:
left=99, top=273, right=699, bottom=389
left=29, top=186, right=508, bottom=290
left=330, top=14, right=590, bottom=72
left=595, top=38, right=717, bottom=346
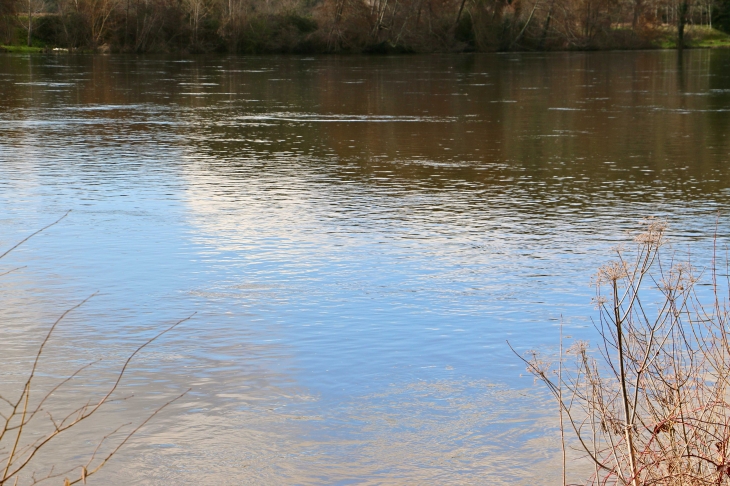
left=0, top=0, right=730, bottom=53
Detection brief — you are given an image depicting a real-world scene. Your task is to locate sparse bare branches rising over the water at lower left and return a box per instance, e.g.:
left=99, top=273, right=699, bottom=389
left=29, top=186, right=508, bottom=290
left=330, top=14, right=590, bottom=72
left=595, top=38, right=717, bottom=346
left=0, top=213, right=192, bottom=486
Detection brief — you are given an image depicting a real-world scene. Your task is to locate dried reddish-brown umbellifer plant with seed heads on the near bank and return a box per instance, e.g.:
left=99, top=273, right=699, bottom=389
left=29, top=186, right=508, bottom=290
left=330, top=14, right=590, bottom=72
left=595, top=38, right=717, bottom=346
left=518, top=219, right=730, bottom=486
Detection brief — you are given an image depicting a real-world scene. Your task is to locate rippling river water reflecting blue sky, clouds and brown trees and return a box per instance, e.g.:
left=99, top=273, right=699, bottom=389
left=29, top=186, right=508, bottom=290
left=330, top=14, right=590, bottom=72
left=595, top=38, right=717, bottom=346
left=0, top=50, right=730, bottom=484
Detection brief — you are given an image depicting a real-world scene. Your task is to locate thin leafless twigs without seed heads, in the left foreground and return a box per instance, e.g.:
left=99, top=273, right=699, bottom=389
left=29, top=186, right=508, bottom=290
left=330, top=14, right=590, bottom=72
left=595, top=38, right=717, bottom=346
left=0, top=213, right=190, bottom=486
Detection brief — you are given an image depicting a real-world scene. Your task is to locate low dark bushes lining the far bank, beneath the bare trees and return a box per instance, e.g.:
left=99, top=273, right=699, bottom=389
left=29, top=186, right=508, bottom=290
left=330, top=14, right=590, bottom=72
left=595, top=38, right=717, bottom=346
left=0, top=16, right=730, bottom=55
